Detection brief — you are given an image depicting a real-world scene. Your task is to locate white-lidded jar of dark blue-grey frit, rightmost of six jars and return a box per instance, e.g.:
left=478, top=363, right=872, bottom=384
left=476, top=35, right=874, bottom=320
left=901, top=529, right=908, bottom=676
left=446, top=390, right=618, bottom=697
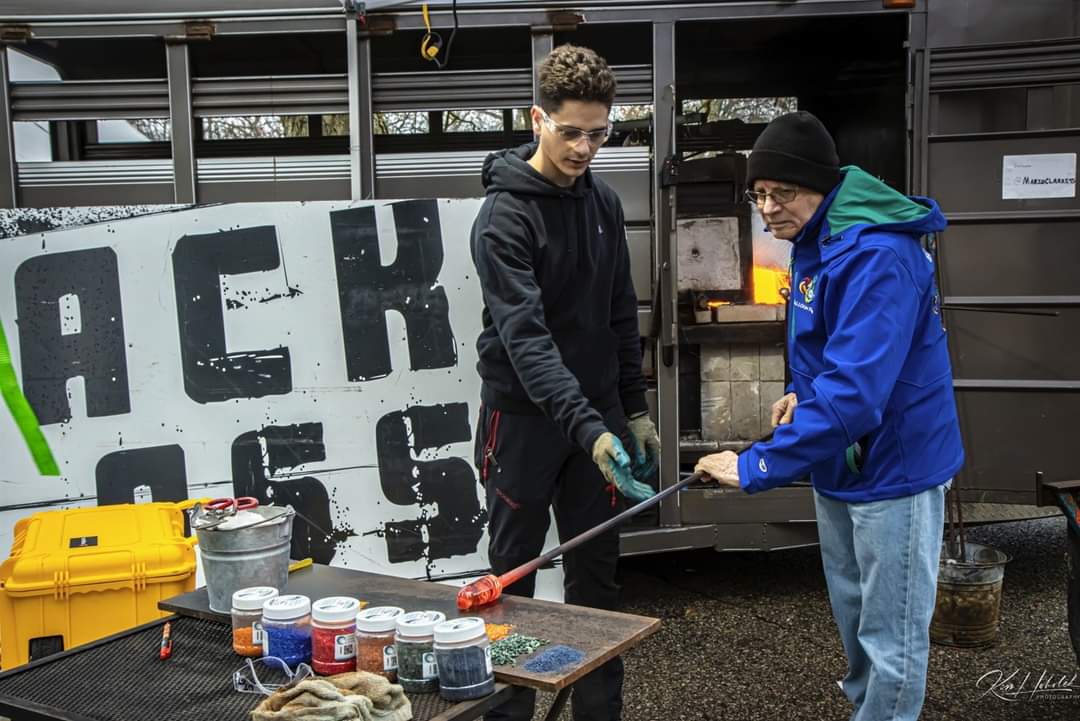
left=434, top=616, right=495, bottom=700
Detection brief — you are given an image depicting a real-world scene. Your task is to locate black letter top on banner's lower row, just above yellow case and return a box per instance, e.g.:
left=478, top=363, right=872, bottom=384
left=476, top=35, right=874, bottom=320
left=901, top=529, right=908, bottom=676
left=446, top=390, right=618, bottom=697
left=94, top=446, right=188, bottom=506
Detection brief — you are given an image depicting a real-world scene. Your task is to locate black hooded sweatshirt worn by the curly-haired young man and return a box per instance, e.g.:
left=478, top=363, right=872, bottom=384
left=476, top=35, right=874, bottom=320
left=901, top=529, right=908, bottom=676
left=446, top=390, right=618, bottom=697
left=471, top=142, right=647, bottom=452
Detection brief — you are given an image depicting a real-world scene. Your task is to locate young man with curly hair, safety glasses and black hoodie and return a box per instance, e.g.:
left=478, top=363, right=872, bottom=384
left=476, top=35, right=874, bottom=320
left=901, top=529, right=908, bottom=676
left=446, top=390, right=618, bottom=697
left=472, top=45, right=660, bottom=721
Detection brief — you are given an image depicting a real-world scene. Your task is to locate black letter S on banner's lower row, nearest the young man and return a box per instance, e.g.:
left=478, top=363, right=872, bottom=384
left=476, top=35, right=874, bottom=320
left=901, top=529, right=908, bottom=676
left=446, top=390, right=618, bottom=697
left=375, top=403, right=487, bottom=563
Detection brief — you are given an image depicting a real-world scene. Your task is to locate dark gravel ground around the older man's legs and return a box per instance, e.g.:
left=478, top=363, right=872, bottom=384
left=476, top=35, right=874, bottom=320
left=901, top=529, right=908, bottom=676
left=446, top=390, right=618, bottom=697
left=536, top=518, right=1080, bottom=721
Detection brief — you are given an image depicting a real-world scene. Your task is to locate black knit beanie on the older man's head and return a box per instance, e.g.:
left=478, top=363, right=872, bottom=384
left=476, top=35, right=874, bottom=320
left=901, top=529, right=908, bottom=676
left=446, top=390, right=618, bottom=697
left=746, top=110, right=840, bottom=194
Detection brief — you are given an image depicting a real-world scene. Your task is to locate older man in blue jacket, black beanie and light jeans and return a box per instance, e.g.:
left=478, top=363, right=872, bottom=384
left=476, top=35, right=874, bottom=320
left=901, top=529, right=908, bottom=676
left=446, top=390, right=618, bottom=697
left=698, top=112, right=963, bottom=721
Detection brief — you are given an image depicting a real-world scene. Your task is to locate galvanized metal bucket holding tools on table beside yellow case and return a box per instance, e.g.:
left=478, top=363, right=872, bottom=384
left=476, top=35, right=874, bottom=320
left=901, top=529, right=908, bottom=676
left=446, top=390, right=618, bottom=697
left=191, top=506, right=296, bottom=613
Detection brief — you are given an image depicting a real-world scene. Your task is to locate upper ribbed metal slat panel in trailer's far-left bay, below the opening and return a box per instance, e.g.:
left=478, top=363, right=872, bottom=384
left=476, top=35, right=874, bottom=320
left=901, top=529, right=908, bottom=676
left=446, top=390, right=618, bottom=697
left=11, top=79, right=168, bottom=121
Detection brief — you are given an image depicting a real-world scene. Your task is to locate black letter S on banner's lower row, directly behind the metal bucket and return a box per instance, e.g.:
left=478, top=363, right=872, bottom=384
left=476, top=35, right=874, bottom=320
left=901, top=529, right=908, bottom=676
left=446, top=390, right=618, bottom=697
left=232, top=423, right=336, bottom=563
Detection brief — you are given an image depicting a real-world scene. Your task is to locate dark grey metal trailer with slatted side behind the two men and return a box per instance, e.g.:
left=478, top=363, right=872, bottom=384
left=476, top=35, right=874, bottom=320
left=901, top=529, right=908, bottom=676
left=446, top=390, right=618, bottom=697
left=0, top=0, right=1080, bottom=653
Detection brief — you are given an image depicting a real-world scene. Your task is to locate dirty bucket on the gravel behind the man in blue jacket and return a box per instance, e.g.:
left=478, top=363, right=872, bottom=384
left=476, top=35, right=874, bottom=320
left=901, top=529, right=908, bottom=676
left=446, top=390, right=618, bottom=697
left=930, top=543, right=1010, bottom=648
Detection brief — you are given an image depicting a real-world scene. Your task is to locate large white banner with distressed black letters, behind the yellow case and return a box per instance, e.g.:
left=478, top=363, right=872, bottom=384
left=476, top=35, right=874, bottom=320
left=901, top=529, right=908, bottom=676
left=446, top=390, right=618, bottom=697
left=0, top=200, right=514, bottom=577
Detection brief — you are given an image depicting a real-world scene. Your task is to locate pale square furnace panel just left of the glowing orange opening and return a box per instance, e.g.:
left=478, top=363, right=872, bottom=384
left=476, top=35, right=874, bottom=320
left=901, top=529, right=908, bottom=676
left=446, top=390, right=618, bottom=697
left=675, top=218, right=742, bottom=290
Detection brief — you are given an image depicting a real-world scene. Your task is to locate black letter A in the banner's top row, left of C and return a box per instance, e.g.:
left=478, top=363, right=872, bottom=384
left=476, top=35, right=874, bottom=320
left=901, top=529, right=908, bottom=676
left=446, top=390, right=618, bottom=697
left=15, top=248, right=131, bottom=425
